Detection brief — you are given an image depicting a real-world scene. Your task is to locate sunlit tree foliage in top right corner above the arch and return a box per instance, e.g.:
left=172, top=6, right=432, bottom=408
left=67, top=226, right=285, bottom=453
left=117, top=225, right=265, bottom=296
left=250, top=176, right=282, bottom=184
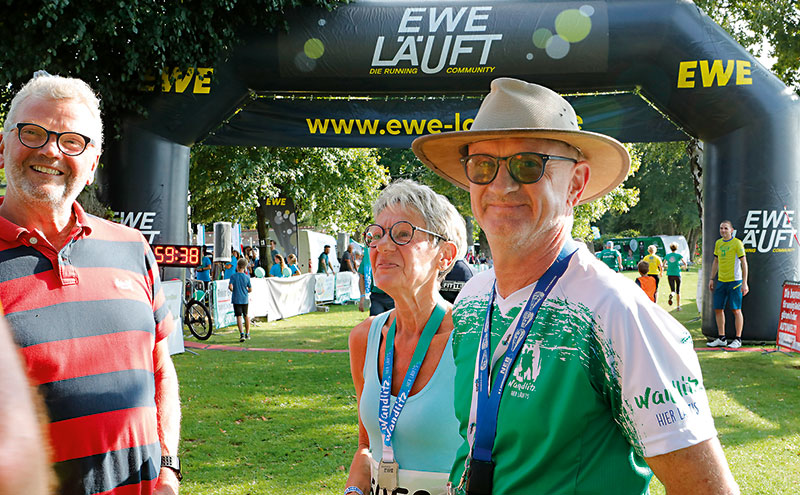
left=695, top=0, right=800, bottom=91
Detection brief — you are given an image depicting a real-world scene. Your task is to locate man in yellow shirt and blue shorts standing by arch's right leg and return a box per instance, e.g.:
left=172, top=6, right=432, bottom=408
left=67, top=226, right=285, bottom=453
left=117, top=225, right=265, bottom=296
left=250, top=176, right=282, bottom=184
left=706, top=220, right=750, bottom=349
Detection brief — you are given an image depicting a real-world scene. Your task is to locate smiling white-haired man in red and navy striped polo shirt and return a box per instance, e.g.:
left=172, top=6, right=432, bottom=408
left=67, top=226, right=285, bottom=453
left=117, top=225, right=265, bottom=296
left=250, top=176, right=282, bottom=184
left=0, top=75, right=181, bottom=495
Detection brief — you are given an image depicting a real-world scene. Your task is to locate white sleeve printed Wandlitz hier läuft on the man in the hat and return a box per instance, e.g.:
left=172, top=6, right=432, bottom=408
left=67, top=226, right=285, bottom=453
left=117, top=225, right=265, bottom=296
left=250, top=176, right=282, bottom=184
left=599, top=292, right=716, bottom=457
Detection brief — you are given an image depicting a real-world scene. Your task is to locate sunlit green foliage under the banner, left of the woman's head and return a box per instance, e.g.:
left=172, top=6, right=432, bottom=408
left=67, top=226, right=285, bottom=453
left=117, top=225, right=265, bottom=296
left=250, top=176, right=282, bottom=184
left=189, top=145, right=388, bottom=232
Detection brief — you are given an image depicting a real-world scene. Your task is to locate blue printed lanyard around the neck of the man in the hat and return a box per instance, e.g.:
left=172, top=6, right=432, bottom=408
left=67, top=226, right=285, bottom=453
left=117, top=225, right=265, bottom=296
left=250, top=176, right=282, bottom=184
left=472, top=244, right=576, bottom=462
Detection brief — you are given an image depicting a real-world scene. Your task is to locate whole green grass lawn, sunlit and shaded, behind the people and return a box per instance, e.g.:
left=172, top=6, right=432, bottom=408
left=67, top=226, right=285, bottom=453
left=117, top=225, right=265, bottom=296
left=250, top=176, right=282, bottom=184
left=174, top=280, right=800, bottom=495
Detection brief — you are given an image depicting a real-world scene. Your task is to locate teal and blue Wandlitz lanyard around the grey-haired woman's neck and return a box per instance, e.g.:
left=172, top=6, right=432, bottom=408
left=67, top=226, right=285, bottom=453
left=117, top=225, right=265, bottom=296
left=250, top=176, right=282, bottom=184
left=378, top=304, right=445, bottom=462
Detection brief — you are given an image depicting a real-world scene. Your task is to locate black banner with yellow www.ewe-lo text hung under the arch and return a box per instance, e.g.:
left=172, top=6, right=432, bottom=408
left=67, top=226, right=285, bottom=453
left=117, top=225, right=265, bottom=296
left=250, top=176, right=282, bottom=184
left=204, top=93, right=687, bottom=147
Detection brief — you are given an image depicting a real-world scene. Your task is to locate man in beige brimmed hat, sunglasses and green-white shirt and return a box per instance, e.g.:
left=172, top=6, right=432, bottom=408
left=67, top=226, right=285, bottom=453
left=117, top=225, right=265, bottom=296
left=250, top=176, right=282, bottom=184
left=412, top=78, right=738, bottom=495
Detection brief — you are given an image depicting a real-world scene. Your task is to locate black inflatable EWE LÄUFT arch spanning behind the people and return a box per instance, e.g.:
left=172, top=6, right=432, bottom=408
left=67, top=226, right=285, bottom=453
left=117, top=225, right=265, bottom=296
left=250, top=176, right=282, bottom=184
left=106, top=0, right=800, bottom=341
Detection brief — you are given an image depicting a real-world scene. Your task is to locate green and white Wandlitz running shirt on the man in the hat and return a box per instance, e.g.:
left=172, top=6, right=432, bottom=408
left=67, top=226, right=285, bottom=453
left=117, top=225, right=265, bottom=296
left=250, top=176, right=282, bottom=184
left=450, top=248, right=716, bottom=495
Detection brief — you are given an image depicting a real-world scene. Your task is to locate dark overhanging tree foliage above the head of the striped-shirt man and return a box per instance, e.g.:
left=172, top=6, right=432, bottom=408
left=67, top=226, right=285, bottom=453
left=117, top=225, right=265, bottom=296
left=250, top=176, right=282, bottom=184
left=0, top=0, right=347, bottom=134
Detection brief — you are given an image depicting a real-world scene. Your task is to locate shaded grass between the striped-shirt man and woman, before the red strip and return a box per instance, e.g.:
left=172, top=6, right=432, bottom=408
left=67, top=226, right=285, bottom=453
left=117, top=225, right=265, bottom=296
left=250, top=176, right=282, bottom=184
left=175, top=351, right=357, bottom=493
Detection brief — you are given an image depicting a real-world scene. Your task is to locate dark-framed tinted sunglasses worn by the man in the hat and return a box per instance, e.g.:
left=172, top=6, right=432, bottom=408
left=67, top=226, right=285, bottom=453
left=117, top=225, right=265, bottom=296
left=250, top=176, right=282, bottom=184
left=461, top=151, right=578, bottom=185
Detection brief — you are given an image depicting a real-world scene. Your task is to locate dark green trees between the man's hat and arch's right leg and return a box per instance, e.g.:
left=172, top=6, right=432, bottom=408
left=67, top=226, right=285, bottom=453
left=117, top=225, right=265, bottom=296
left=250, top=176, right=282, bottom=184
left=599, top=142, right=701, bottom=252
